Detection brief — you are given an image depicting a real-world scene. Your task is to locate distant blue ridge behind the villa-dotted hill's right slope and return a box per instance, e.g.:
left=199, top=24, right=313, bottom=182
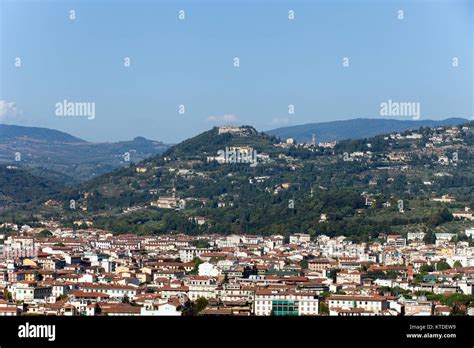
left=265, top=118, right=468, bottom=142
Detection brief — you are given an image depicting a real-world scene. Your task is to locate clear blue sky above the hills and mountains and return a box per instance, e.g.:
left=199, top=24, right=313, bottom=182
left=0, top=0, right=474, bottom=142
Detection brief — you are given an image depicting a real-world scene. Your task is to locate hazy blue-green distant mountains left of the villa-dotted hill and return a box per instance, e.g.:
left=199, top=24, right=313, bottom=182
left=0, top=124, right=169, bottom=183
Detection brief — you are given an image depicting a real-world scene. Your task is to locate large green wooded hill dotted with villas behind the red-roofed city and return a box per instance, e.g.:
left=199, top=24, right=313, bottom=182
left=3, top=122, right=474, bottom=240
